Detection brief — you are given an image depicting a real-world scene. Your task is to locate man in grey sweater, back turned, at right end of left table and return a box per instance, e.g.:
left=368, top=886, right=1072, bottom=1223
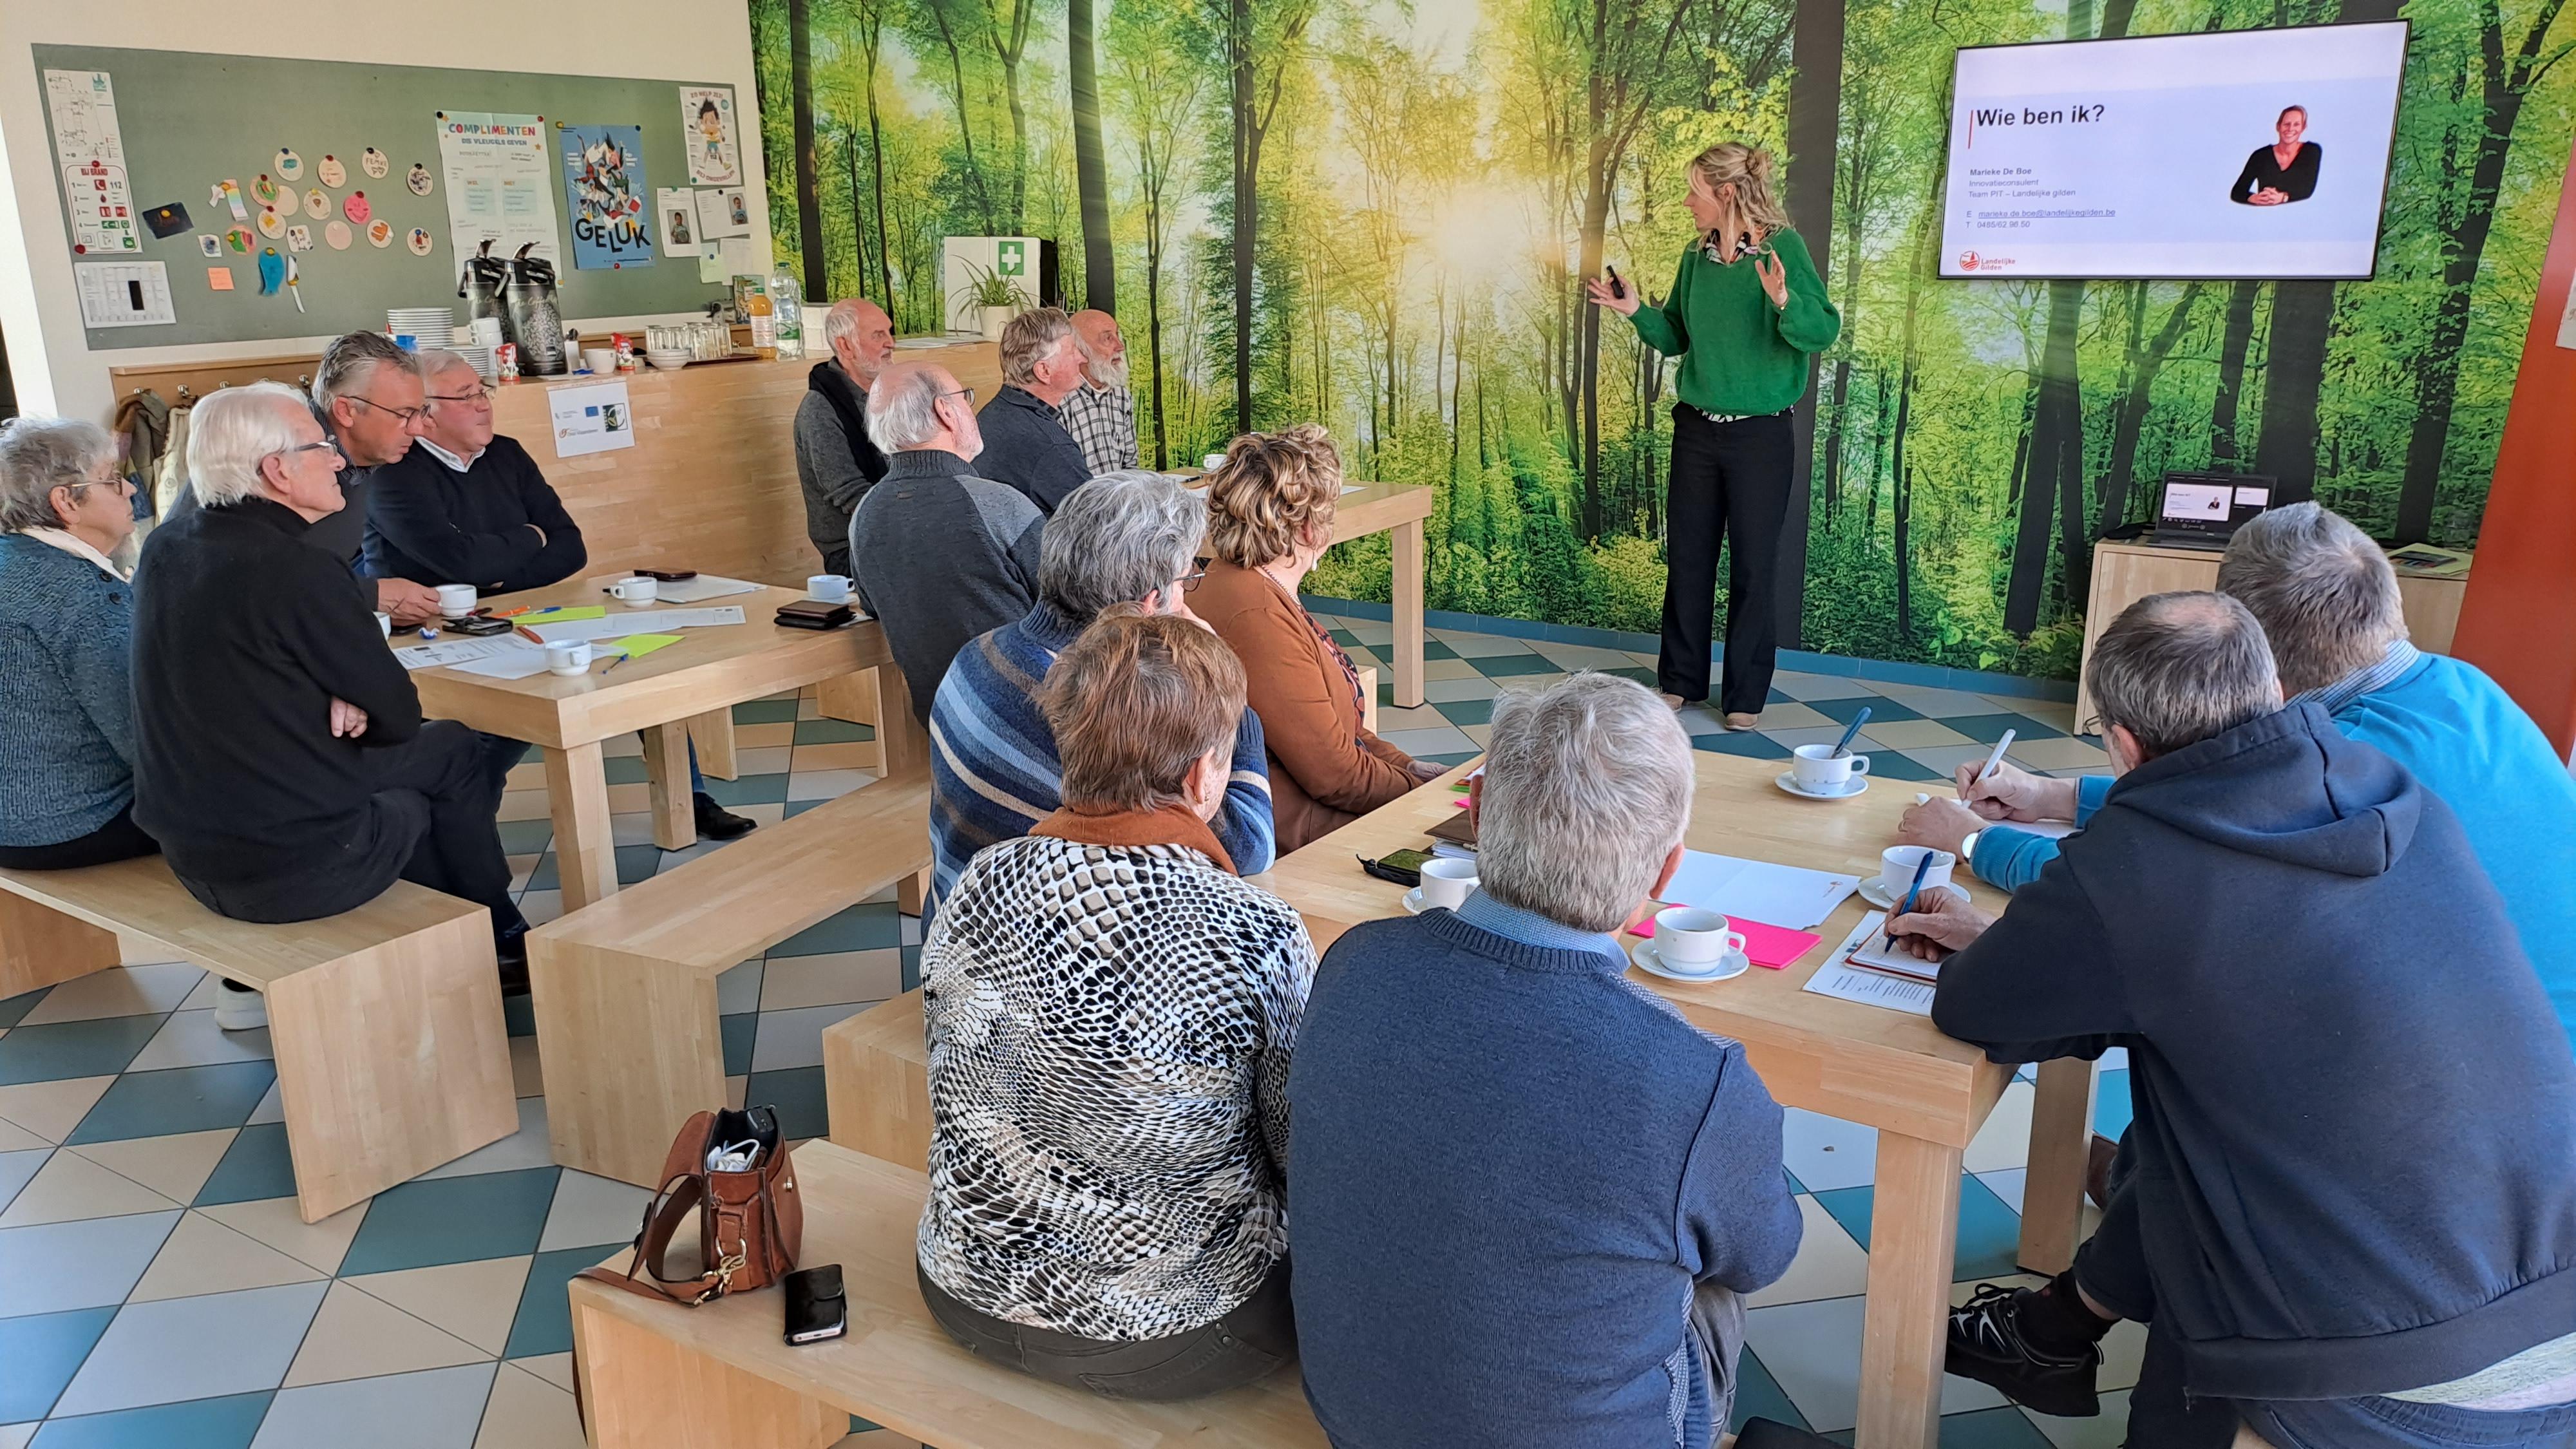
left=850, top=364, right=1046, bottom=724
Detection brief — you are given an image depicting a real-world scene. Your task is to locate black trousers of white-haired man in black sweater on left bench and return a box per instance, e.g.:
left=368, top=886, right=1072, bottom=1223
left=178, top=719, right=528, bottom=941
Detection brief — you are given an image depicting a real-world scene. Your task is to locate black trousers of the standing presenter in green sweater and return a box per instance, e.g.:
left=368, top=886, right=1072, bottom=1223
left=1654, top=405, right=1798, bottom=714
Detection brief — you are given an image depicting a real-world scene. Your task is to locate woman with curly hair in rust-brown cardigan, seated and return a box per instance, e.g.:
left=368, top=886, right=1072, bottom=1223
left=1188, top=426, right=1440, bottom=856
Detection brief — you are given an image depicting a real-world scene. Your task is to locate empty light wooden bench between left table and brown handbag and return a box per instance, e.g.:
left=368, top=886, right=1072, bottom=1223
left=528, top=773, right=930, bottom=1186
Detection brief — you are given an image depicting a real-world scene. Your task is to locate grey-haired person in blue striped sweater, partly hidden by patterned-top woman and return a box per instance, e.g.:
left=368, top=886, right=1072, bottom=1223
left=930, top=472, right=1278, bottom=900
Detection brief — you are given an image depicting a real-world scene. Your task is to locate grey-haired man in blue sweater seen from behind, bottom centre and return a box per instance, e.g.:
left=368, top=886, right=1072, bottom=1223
left=1288, top=673, right=1801, bottom=1449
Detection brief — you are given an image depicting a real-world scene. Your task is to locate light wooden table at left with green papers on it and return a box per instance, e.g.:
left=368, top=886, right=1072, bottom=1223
left=394, top=575, right=927, bottom=913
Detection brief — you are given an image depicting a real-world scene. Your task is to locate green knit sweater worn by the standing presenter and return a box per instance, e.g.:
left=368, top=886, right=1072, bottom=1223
left=1631, top=232, right=1842, bottom=415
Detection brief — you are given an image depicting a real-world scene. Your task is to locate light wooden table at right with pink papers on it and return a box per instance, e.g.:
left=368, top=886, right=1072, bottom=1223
left=1252, top=753, right=2092, bottom=1449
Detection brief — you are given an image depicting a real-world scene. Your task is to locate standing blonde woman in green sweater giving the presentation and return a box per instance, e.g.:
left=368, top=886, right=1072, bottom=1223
left=1584, top=142, right=1842, bottom=730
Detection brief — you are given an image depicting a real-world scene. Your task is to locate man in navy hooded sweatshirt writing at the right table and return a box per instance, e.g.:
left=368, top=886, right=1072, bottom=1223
left=1893, top=593, right=2576, bottom=1449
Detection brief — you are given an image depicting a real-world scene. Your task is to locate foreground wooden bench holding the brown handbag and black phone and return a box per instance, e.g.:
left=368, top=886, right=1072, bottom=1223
left=569, top=1142, right=1324, bottom=1449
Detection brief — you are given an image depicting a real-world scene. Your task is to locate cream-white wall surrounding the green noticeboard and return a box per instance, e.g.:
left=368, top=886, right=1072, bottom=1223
left=0, top=0, right=770, bottom=423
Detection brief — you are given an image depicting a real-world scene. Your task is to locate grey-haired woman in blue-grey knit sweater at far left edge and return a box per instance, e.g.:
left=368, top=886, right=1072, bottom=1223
left=0, top=418, right=160, bottom=871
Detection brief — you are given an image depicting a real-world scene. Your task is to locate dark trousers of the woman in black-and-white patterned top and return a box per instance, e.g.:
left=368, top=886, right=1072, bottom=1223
left=914, top=1258, right=1296, bottom=1400
